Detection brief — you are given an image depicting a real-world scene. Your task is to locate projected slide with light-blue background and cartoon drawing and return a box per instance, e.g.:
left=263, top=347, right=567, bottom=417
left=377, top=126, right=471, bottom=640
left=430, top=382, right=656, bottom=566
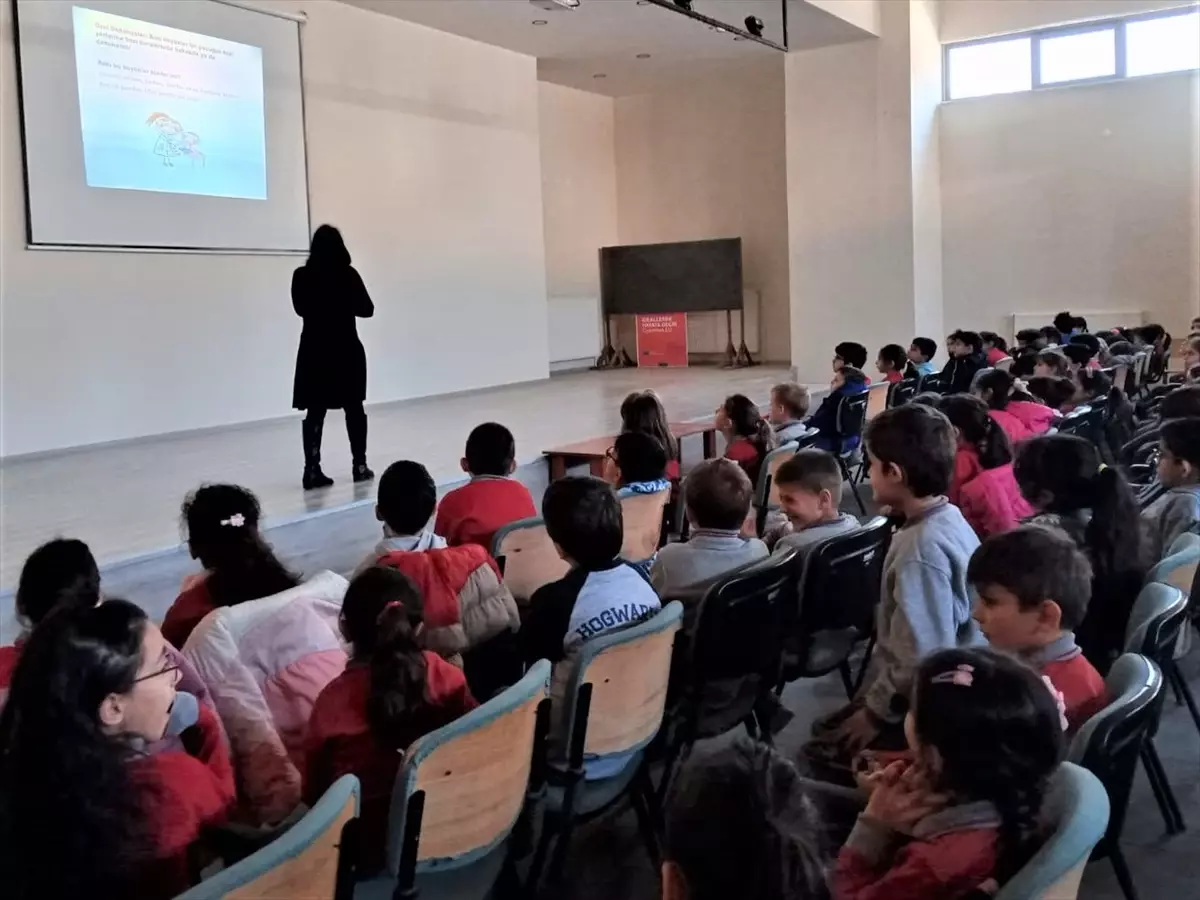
left=72, top=6, right=266, bottom=200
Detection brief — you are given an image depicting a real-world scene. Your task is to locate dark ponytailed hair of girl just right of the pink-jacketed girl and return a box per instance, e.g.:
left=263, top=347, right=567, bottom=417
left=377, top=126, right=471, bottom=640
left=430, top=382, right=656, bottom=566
left=1013, top=434, right=1145, bottom=578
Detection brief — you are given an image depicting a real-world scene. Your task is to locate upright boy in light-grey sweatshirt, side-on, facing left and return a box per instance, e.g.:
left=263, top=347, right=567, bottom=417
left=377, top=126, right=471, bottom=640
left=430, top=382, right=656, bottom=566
left=805, top=403, right=979, bottom=768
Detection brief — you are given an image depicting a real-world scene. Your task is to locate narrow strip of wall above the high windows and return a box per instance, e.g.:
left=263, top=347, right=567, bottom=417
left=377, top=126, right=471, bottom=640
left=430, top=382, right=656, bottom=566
left=940, top=0, right=1196, bottom=42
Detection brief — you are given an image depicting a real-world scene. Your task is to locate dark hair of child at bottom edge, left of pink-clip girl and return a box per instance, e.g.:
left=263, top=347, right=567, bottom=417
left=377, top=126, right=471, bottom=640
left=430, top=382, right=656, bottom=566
left=664, top=737, right=824, bottom=900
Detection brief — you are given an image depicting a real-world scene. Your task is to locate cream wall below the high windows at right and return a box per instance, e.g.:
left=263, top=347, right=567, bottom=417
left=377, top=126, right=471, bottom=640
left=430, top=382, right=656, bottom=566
left=941, top=73, right=1200, bottom=335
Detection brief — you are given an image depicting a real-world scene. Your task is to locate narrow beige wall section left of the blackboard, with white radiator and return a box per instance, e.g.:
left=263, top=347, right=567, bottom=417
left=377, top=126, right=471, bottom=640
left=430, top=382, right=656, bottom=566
left=538, top=82, right=619, bottom=362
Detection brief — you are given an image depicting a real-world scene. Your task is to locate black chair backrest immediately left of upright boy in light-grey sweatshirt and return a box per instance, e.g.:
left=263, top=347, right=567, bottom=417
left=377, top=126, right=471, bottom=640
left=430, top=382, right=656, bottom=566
left=794, top=516, right=892, bottom=652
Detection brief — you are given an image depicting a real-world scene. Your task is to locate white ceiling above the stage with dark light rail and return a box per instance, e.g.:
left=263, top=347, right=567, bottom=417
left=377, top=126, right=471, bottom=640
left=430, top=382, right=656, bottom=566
left=343, top=0, right=869, bottom=96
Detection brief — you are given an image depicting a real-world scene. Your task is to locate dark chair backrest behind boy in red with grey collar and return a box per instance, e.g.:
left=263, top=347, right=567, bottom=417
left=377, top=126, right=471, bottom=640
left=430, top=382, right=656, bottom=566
left=1067, top=653, right=1163, bottom=835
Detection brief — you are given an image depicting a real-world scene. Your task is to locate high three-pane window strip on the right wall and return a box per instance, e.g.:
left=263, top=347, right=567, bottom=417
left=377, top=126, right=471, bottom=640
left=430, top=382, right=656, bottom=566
left=944, top=8, right=1200, bottom=100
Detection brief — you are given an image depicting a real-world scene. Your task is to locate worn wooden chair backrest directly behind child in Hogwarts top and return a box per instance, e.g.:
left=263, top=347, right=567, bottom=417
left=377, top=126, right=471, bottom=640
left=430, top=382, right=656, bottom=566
left=565, top=601, right=683, bottom=758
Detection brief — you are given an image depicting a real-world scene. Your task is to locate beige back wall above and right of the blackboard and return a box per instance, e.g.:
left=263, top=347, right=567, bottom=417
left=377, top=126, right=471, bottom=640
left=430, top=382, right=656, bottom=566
left=616, top=54, right=791, bottom=361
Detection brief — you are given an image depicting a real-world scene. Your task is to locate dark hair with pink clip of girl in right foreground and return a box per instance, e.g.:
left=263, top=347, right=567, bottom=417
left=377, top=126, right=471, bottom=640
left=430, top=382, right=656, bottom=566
left=912, top=649, right=1064, bottom=883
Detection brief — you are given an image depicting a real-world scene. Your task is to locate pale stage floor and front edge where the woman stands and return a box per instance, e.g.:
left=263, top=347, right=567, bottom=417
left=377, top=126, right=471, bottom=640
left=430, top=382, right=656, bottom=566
left=7, top=366, right=806, bottom=643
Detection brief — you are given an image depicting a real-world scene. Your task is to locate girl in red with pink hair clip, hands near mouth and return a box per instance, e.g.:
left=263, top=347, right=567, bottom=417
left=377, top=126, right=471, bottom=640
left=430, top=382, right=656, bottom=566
left=830, top=649, right=1066, bottom=900
